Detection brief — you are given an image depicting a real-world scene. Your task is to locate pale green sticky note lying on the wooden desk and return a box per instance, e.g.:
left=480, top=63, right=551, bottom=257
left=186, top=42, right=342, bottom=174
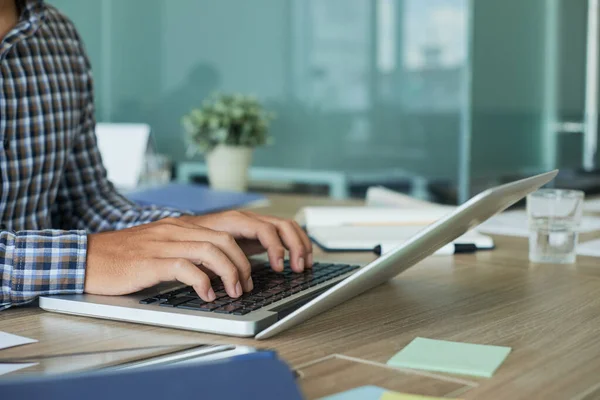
left=387, top=338, right=510, bottom=378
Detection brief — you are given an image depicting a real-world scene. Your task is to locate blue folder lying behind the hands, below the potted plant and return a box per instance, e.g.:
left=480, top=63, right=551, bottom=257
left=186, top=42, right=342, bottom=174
left=125, top=183, right=265, bottom=214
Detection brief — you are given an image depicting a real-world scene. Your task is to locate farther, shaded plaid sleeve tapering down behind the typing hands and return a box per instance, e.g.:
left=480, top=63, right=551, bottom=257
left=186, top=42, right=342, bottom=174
left=52, top=32, right=182, bottom=232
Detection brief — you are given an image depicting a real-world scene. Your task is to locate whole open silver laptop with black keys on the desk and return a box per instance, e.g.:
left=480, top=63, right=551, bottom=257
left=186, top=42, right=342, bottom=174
left=39, top=170, right=558, bottom=339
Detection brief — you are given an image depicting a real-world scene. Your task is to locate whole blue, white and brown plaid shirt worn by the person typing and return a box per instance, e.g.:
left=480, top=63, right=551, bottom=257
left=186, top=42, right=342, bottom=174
left=0, top=0, right=180, bottom=310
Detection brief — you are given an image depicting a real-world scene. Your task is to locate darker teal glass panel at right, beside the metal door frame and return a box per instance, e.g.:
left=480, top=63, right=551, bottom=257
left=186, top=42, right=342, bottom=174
left=472, top=0, right=548, bottom=178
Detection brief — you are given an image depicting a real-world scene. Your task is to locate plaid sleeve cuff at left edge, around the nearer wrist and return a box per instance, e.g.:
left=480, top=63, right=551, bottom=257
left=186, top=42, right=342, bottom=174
left=0, top=230, right=87, bottom=310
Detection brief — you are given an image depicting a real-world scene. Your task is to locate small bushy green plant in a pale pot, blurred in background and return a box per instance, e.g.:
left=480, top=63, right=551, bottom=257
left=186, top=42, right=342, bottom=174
left=182, top=94, right=273, bottom=191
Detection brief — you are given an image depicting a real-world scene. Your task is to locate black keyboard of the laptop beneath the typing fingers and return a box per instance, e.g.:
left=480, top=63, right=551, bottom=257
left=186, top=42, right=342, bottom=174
left=140, top=261, right=360, bottom=315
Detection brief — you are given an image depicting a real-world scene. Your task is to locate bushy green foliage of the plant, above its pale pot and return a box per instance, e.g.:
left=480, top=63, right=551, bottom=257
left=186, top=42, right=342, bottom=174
left=182, top=94, right=274, bottom=154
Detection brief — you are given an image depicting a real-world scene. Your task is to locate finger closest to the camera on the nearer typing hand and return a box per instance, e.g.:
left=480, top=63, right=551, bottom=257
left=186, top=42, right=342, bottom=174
left=152, top=258, right=217, bottom=302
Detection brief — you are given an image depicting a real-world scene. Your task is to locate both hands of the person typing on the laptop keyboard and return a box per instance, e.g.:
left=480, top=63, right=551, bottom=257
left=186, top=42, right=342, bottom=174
left=85, top=211, right=312, bottom=301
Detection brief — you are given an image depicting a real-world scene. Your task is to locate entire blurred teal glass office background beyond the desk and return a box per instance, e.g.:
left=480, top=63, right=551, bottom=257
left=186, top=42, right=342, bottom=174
left=50, top=0, right=600, bottom=203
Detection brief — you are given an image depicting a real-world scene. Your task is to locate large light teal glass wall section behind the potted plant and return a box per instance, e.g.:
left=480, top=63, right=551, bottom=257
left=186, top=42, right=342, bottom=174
left=51, top=0, right=467, bottom=184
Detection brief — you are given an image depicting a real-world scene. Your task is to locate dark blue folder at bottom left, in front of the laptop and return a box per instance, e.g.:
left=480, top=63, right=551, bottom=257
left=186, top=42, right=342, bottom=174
left=0, top=352, right=302, bottom=400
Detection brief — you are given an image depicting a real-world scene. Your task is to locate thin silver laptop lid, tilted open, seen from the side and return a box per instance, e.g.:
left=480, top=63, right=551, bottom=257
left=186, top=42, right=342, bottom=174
left=256, top=170, right=558, bottom=339
